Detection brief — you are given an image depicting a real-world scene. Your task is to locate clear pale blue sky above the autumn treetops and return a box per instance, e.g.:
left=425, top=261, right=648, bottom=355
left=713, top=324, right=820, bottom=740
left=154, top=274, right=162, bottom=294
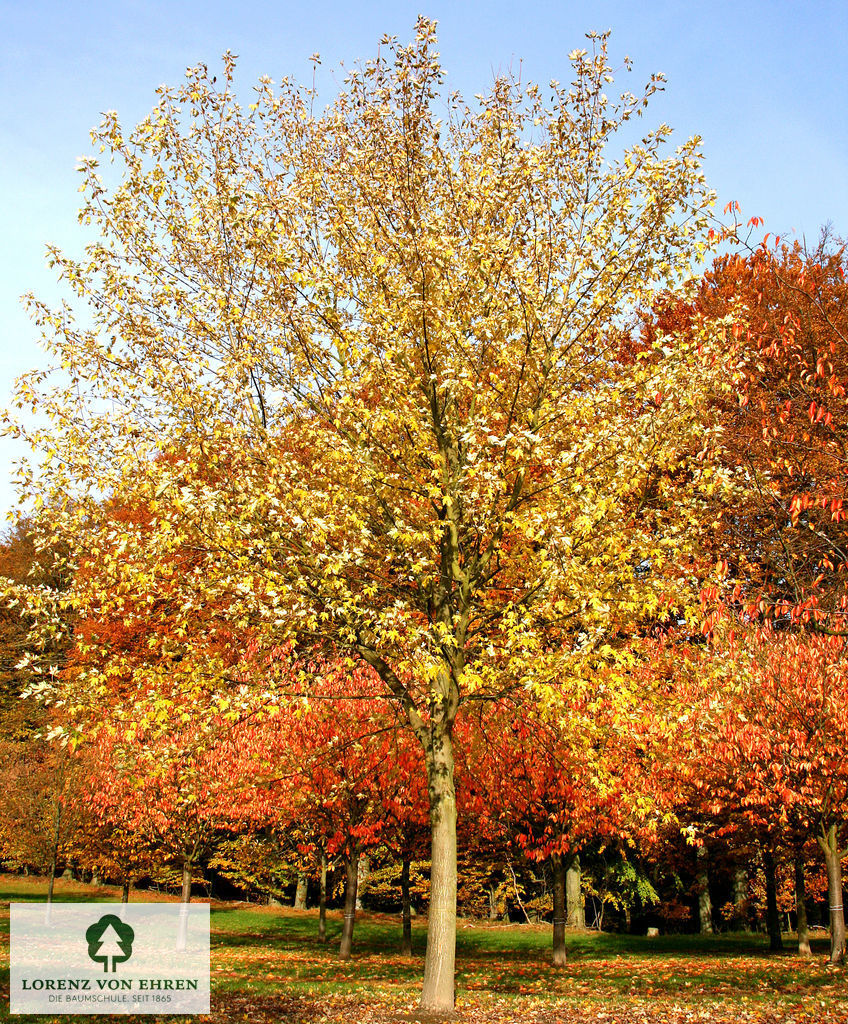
left=0, top=0, right=848, bottom=518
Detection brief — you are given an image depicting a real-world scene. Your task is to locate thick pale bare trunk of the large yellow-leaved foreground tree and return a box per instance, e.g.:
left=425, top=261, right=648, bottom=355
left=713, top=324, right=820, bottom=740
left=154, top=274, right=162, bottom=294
left=421, top=723, right=457, bottom=1014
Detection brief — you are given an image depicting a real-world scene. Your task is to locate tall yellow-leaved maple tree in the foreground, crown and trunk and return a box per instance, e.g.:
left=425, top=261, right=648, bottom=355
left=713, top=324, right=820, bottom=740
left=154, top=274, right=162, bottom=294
left=9, top=18, right=722, bottom=1011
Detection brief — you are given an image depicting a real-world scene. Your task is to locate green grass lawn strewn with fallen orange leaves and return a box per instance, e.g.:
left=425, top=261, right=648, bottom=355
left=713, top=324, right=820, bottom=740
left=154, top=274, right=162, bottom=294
left=0, top=876, right=848, bottom=1024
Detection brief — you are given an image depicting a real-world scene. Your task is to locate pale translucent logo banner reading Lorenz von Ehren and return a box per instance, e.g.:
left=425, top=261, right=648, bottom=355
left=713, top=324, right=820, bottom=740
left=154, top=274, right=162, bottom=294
left=9, top=903, right=209, bottom=1015
